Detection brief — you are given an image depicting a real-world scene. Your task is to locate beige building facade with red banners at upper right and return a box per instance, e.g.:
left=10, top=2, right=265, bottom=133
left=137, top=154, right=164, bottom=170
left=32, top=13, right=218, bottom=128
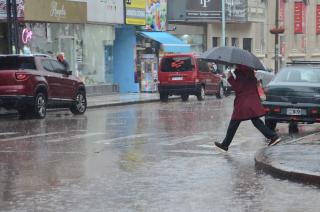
left=266, top=0, right=320, bottom=67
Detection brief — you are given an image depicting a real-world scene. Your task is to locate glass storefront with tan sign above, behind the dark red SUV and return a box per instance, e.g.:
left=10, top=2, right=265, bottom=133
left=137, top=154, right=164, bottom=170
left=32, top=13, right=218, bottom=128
left=23, top=0, right=115, bottom=90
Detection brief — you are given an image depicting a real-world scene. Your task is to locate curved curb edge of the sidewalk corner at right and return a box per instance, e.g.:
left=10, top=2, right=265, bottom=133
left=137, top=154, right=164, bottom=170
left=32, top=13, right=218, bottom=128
left=255, top=147, right=320, bottom=186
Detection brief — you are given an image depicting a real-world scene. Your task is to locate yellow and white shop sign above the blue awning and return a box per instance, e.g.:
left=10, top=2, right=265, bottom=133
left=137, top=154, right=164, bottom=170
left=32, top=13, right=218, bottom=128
left=126, top=0, right=146, bottom=26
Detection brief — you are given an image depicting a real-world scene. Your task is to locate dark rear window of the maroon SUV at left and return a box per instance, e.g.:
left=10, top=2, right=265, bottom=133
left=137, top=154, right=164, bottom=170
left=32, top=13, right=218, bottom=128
left=0, top=56, right=36, bottom=70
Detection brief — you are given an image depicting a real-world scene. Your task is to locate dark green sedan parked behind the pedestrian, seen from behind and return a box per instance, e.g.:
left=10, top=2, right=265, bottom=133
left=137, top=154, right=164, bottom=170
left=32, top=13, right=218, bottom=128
left=263, top=64, right=320, bottom=130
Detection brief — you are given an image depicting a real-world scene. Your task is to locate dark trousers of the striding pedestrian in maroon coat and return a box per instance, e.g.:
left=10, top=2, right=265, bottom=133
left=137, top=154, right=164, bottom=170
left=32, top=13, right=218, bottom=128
left=222, top=117, right=278, bottom=147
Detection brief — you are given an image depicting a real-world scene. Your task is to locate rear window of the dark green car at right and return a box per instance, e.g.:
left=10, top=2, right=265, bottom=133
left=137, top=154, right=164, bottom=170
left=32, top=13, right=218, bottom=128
left=274, top=67, right=320, bottom=83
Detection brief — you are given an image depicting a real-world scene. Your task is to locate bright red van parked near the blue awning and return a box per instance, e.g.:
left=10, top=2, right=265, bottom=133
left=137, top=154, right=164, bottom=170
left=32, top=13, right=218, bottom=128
left=158, top=54, right=223, bottom=102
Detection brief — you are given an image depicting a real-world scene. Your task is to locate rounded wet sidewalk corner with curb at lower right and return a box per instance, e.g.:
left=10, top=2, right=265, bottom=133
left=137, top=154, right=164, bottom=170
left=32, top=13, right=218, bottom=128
left=255, top=133, right=320, bottom=186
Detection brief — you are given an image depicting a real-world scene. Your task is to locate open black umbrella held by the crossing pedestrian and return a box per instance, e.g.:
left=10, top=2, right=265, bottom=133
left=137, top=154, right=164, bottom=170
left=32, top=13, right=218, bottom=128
left=200, top=47, right=265, bottom=70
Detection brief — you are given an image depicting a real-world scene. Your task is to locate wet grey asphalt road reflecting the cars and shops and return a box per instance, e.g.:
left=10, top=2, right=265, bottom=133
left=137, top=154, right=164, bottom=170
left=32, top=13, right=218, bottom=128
left=0, top=97, right=320, bottom=212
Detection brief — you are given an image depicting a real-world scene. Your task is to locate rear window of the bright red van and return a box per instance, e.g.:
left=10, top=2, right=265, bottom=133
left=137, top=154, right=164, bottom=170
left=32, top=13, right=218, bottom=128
left=161, top=57, right=194, bottom=72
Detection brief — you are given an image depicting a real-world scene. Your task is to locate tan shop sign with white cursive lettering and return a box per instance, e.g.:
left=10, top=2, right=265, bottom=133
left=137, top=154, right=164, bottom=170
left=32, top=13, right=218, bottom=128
left=25, top=0, right=87, bottom=23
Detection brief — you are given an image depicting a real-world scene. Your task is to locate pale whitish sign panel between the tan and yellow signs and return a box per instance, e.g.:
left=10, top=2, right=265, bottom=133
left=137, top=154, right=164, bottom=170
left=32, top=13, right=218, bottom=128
left=87, top=0, right=124, bottom=24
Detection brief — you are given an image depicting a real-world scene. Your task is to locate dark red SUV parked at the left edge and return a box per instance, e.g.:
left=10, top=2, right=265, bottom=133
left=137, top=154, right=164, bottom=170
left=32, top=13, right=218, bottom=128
left=0, top=55, right=87, bottom=119
